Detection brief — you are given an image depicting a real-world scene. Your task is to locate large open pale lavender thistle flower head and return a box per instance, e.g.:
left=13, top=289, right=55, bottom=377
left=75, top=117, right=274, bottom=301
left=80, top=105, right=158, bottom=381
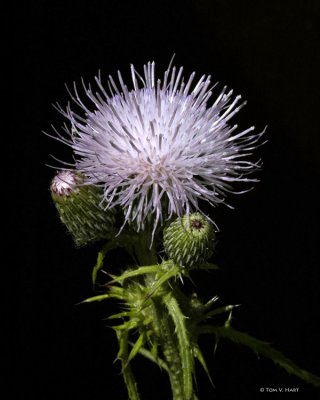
left=50, top=62, right=263, bottom=238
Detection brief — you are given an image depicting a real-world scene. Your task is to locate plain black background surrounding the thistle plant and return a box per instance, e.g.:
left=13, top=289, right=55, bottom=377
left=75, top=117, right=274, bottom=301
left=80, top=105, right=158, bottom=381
left=13, top=0, right=320, bottom=400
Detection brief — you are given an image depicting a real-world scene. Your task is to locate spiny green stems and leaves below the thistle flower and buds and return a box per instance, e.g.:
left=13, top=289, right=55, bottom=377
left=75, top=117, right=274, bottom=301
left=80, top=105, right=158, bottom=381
left=80, top=235, right=320, bottom=400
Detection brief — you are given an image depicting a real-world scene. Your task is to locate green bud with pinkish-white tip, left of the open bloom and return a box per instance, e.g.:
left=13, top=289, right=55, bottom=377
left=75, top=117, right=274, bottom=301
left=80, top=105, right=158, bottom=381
left=50, top=171, right=115, bottom=246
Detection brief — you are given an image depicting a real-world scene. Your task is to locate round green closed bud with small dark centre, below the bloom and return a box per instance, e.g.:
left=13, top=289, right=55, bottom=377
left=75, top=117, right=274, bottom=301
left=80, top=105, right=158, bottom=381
left=164, top=213, right=215, bottom=268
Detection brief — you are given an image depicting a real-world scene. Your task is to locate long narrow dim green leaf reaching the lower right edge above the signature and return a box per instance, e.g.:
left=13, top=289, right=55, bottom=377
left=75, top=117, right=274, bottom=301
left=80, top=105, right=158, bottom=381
left=200, top=326, right=320, bottom=387
